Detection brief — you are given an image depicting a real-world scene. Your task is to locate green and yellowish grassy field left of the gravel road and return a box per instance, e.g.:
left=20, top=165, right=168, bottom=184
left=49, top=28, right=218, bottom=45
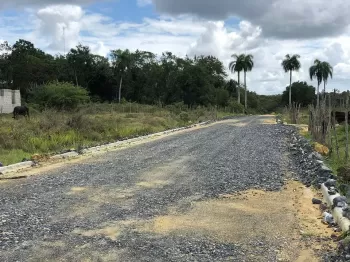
left=0, top=103, right=232, bottom=165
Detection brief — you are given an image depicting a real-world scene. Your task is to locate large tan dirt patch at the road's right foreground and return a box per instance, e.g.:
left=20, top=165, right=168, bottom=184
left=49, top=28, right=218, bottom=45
left=135, top=181, right=333, bottom=261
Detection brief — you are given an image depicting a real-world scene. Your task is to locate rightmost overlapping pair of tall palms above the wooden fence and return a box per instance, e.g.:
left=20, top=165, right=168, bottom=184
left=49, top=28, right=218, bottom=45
left=309, top=59, right=333, bottom=106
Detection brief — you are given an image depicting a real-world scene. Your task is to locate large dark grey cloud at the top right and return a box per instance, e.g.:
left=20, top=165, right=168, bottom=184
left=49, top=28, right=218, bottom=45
left=153, top=0, right=350, bottom=39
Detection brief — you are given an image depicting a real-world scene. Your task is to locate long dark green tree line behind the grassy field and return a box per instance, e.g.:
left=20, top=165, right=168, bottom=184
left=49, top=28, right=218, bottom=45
left=0, top=39, right=330, bottom=113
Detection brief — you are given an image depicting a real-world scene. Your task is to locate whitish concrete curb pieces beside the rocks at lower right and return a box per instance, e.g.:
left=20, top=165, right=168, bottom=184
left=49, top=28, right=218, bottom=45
left=321, top=184, right=350, bottom=232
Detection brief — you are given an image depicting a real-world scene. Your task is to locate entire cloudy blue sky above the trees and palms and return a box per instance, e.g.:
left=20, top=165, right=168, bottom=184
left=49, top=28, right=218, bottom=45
left=0, top=0, right=350, bottom=94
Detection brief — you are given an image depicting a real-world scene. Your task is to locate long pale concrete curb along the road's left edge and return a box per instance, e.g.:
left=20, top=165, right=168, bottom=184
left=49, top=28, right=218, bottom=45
left=0, top=120, right=220, bottom=176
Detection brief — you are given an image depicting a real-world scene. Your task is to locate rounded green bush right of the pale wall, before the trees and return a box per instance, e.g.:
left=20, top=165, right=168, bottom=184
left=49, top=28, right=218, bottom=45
left=30, top=82, right=89, bottom=110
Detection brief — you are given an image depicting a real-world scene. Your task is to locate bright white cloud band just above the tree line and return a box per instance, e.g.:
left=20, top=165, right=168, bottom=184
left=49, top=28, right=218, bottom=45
left=0, top=5, right=350, bottom=94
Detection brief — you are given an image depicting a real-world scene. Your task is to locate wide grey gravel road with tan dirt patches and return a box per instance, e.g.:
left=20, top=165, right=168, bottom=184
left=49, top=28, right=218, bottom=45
left=0, top=116, right=326, bottom=262
